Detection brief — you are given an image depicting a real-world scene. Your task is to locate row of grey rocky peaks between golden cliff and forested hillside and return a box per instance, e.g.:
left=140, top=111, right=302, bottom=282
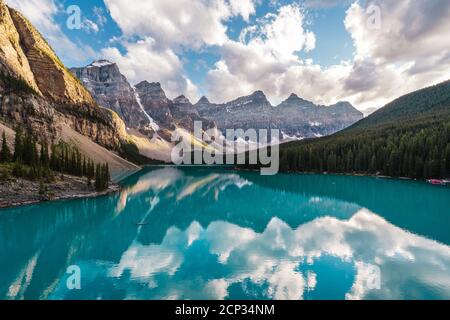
left=71, top=60, right=363, bottom=146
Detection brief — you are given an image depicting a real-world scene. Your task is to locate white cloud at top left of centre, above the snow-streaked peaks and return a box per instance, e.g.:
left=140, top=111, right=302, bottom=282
left=102, top=0, right=255, bottom=101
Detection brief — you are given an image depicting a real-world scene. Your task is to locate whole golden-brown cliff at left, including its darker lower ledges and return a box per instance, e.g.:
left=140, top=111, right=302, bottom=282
left=0, top=0, right=132, bottom=156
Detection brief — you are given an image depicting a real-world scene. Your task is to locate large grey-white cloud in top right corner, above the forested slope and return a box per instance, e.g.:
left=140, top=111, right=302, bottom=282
left=344, top=0, right=450, bottom=107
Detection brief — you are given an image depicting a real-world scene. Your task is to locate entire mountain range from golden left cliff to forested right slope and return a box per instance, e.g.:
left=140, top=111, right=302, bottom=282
left=9, top=0, right=442, bottom=178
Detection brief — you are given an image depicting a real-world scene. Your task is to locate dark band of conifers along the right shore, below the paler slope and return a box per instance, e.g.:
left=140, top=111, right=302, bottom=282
left=280, top=121, right=450, bottom=179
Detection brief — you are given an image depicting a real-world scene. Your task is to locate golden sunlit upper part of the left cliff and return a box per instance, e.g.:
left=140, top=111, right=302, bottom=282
left=0, top=3, right=94, bottom=105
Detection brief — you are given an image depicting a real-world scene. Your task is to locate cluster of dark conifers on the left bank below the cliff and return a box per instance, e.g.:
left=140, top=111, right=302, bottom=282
left=0, top=126, right=111, bottom=191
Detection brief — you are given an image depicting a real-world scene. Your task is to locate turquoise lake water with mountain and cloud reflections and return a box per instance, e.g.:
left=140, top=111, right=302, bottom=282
left=0, top=167, right=450, bottom=299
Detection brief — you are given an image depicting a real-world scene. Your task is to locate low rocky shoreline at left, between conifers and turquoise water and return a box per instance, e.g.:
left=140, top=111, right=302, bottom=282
left=0, top=175, right=120, bottom=208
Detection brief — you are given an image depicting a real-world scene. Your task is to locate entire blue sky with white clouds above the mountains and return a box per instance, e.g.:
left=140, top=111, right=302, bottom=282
left=6, top=0, right=450, bottom=112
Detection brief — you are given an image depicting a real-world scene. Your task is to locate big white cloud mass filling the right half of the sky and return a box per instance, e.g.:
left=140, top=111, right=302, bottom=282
left=207, top=0, right=450, bottom=110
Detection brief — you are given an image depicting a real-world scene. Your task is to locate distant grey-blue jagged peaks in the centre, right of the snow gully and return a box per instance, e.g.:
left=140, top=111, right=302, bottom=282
left=195, top=91, right=363, bottom=138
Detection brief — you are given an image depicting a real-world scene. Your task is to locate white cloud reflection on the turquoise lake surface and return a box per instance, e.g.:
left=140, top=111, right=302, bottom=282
left=109, top=209, right=450, bottom=300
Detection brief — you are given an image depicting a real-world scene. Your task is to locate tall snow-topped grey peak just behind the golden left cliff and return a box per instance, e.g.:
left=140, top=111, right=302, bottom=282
left=71, top=60, right=149, bottom=128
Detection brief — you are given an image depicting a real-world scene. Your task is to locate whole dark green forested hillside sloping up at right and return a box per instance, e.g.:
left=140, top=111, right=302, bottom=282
left=280, top=81, right=450, bottom=179
